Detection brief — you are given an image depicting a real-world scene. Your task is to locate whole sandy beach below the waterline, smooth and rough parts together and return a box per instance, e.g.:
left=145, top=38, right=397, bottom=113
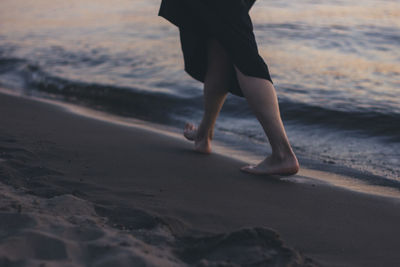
left=0, top=93, right=400, bottom=266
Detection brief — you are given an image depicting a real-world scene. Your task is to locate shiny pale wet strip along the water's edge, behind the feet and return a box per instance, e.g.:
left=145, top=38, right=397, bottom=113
left=0, top=87, right=400, bottom=199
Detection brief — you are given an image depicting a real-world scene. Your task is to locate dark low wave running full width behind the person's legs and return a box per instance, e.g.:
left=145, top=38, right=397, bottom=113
left=0, top=58, right=400, bottom=142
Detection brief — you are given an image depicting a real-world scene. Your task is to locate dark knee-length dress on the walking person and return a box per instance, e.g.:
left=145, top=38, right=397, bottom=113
left=158, top=0, right=272, bottom=96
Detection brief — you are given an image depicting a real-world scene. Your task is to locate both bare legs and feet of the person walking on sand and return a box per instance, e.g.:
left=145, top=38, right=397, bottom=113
left=184, top=39, right=299, bottom=174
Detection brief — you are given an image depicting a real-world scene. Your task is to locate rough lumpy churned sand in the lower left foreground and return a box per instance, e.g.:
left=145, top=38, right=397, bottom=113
left=0, top=184, right=312, bottom=266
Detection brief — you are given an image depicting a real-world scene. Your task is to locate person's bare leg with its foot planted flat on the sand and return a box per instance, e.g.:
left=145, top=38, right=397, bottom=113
left=235, top=66, right=299, bottom=175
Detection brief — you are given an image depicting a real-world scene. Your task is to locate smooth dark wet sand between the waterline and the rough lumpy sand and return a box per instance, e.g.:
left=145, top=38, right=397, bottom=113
left=0, top=90, right=400, bottom=266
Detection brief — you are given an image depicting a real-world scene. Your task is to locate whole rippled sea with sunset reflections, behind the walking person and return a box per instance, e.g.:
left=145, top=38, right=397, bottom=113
left=0, top=0, right=400, bottom=185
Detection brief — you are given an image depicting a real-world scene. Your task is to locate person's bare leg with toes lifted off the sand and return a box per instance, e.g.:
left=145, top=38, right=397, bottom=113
left=184, top=39, right=231, bottom=154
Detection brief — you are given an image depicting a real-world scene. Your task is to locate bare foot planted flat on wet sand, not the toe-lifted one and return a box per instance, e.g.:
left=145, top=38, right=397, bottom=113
left=240, top=154, right=299, bottom=176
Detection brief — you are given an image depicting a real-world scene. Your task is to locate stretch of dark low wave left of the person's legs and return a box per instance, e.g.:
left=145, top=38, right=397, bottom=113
left=0, top=59, right=201, bottom=123
